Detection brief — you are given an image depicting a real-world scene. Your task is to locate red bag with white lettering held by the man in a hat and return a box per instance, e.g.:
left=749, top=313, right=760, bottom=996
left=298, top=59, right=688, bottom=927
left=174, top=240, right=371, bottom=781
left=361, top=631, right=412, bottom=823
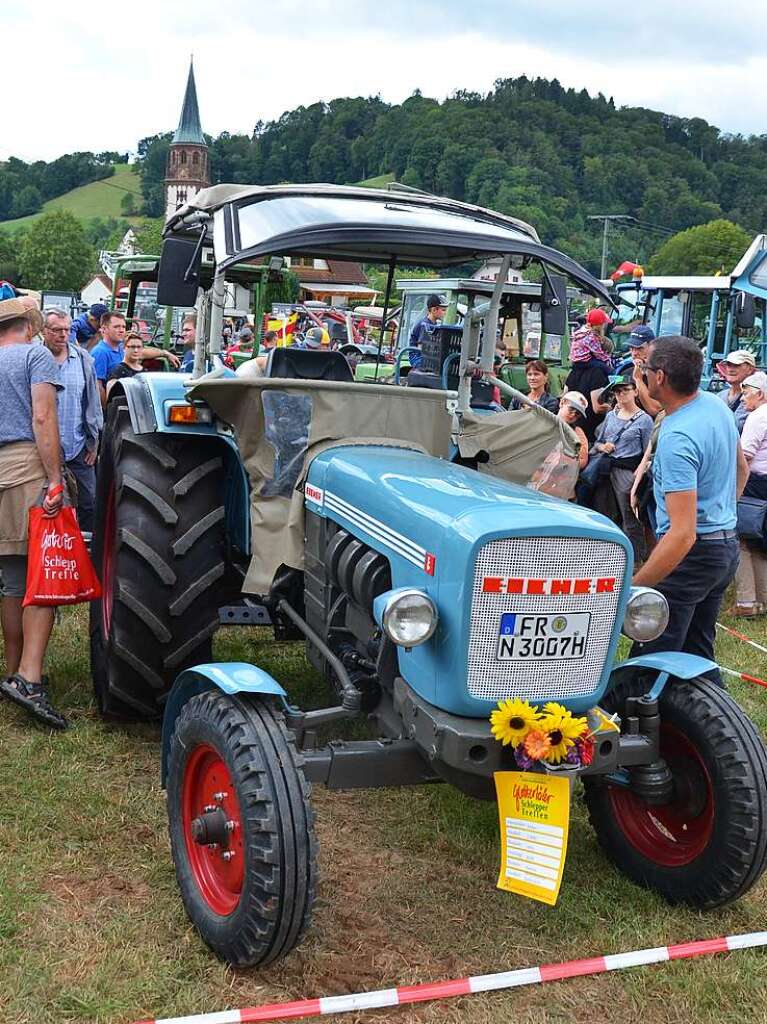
left=24, top=507, right=101, bottom=607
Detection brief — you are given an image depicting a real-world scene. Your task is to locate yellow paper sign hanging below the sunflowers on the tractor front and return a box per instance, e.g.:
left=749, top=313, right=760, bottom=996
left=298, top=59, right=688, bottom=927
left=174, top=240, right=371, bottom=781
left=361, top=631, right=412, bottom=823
left=495, top=771, right=570, bottom=906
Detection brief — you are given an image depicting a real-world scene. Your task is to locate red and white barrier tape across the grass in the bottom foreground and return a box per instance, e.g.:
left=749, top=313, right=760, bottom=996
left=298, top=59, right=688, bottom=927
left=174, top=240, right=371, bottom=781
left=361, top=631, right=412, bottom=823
left=137, top=932, right=767, bottom=1024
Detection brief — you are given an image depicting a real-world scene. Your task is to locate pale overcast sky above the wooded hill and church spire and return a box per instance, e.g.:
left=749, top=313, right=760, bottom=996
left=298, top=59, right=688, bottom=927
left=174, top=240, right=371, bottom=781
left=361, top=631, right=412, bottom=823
left=0, top=0, right=767, bottom=160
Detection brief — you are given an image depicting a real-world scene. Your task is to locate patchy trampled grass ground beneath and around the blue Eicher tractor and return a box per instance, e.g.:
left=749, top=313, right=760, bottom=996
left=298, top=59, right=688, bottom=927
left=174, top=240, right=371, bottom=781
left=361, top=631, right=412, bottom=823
left=0, top=608, right=767, bottom=1024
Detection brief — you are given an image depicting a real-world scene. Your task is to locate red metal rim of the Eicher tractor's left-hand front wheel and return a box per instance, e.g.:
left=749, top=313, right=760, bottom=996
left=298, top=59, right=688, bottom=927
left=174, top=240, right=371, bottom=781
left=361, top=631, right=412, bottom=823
left=181, top=743, right=245, bottom=916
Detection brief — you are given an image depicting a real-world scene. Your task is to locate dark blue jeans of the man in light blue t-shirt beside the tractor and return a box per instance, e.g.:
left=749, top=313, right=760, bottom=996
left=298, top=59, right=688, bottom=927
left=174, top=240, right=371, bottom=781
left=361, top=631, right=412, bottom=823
left=631, top=537, right=739, bottom=686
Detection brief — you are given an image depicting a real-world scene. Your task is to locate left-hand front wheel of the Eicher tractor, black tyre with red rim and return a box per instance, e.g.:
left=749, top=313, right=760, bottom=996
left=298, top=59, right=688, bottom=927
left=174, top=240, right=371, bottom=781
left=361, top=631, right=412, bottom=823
left=167, top=690, right=316, bottom=967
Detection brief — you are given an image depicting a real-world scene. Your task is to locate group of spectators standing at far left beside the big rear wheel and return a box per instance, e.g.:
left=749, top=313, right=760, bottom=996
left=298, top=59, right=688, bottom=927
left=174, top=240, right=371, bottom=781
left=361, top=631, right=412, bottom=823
left=0, top=297, right=185, bottom=729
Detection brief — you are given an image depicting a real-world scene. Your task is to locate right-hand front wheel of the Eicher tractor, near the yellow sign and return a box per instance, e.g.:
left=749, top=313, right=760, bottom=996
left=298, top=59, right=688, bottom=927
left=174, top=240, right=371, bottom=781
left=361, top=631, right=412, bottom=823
left=584, top=676, right=767, bottom=909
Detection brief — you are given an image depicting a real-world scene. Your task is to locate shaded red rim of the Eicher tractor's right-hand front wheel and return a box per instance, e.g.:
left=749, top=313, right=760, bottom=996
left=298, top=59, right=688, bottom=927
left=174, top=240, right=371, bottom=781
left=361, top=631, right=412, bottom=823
left=609, top=725, right=714, bottom=867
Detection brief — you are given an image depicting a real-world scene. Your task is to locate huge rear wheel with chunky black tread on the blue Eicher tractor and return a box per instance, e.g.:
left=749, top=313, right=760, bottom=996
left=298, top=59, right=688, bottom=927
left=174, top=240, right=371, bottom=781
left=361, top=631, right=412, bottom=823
left=90, top=398, right=225, bottom=718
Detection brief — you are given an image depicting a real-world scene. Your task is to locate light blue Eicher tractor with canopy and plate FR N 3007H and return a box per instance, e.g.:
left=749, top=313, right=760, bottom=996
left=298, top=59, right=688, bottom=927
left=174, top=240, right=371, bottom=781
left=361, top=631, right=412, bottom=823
left=91, top=185, right=767, bottom=965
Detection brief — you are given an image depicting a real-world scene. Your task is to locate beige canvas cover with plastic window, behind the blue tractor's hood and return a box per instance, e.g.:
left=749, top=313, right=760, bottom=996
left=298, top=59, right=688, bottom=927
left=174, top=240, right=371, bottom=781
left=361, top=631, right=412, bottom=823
left=189, top=377, right=452, bottom=595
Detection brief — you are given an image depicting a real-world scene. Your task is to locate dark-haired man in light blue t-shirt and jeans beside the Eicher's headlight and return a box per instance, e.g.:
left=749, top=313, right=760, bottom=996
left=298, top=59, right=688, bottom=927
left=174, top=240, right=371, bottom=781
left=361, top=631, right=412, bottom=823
left=632, top=336, right=749, bottom=686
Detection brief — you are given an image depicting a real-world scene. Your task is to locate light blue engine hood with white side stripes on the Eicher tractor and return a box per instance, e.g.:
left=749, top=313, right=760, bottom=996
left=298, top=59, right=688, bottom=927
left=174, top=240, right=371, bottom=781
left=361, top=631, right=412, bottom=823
left=305, top=445, right=632, bottom=717
